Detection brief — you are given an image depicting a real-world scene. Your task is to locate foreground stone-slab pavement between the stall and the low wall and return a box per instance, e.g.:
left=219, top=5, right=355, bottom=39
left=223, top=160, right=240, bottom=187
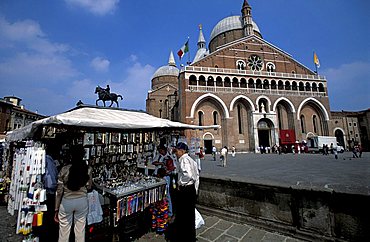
left=137, top=215, right=302, bottom=242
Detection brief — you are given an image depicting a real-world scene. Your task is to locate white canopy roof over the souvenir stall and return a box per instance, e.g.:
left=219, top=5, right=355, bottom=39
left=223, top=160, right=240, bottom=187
left=6, top=105, right=220, bottom=141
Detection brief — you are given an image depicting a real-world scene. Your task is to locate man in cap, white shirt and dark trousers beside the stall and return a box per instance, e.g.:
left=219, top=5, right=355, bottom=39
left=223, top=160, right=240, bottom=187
left=175, top=142, right=199, bottom=242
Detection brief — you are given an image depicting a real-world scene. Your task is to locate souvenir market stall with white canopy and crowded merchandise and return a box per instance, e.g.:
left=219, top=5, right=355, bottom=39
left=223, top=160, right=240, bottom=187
left=6, top=105, right=218, bottom=241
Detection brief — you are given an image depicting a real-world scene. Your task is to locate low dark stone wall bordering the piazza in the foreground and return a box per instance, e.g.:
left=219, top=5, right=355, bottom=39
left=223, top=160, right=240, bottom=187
left=198, top=177, right=370, bottom=241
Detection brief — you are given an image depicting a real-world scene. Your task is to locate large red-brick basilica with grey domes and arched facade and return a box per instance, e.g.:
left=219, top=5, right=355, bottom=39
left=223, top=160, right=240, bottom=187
left=146, top=0, right=360, bottom=152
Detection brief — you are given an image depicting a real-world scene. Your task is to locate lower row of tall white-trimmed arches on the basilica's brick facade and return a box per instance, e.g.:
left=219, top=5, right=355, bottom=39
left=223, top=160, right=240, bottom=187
left=191, top=95, right=329, bottom=152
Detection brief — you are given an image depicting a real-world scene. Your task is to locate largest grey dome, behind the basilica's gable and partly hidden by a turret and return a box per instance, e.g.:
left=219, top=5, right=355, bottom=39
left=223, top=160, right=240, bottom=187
left=210, top=16, right=261, bottom=41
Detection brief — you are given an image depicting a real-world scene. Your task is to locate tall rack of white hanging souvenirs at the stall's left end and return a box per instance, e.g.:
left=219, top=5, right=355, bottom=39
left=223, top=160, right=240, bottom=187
left=8, top=141, right=47, bottom=239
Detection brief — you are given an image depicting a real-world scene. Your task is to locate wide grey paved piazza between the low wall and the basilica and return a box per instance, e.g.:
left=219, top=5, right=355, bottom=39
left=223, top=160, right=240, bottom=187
left=201, top=152, right=370, bottom=195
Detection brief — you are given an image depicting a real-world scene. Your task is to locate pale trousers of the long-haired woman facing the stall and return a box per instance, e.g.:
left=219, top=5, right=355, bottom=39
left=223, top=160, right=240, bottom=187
left=58, top=197, right=88, bottom=242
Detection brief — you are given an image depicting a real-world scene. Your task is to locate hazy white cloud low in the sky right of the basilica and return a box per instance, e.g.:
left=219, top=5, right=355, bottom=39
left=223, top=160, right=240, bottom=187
left=321, top=62, right=370, bottom=111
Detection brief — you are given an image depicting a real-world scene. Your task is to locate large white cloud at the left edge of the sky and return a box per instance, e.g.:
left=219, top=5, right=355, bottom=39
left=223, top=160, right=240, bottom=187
left=0, top=18, right=79, bottom=88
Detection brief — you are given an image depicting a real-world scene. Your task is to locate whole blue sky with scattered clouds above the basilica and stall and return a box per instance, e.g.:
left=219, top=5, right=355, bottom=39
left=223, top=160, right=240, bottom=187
left=0, top=0, right=370, bottom=115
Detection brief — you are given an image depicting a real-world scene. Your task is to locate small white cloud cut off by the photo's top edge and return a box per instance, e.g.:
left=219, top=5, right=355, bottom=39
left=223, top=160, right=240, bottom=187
left=65, top=0, right=119, bottom=16
